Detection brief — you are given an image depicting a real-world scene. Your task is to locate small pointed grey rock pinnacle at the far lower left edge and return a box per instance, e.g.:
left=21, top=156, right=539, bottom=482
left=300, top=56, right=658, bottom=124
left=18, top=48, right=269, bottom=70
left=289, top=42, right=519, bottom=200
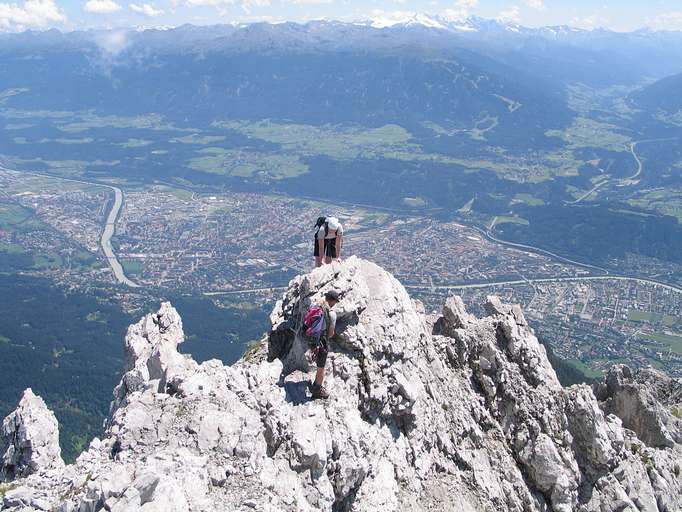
left=0, top=388, right=64, bottom=482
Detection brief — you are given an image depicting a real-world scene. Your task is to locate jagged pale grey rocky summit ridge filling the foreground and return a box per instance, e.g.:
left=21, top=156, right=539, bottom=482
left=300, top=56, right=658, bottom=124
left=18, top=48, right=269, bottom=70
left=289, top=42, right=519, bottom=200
left=0, top=257, right=682, bottom=512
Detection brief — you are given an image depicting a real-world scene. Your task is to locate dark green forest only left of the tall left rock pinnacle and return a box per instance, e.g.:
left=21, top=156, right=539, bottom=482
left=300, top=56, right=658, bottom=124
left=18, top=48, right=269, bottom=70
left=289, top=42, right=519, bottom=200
left=0, top=275, right=131, bottom=460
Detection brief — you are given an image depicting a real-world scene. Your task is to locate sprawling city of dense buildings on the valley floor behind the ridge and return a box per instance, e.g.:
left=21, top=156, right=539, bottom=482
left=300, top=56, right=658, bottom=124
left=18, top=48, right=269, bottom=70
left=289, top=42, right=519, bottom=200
left=0, top=170, right=682, bottom=376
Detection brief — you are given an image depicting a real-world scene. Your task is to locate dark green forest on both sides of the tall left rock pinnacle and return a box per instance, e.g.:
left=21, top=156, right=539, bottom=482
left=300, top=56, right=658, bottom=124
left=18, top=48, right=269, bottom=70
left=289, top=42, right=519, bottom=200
left=0, top=275, right=268, bottom=461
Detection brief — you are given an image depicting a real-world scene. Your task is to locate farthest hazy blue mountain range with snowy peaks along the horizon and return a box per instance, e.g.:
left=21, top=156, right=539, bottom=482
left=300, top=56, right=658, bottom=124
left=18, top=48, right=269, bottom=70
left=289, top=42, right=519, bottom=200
left=7, top=15, right=682, bottom=84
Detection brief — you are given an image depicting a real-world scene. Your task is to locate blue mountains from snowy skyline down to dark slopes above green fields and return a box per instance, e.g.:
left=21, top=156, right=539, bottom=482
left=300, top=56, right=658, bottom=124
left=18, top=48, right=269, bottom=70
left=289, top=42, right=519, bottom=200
left=0, top=16, right=682, bottom=156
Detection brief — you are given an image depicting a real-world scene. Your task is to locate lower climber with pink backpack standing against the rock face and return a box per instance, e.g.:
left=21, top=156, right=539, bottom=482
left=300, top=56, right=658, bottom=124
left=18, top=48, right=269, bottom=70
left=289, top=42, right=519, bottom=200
left=303, top=290, right=339, bottom=398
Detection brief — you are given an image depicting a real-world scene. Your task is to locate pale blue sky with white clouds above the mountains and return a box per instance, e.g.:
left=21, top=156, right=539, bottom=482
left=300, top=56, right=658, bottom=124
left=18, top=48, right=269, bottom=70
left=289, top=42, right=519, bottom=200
left=0, top=0, right=682, bottom=31
